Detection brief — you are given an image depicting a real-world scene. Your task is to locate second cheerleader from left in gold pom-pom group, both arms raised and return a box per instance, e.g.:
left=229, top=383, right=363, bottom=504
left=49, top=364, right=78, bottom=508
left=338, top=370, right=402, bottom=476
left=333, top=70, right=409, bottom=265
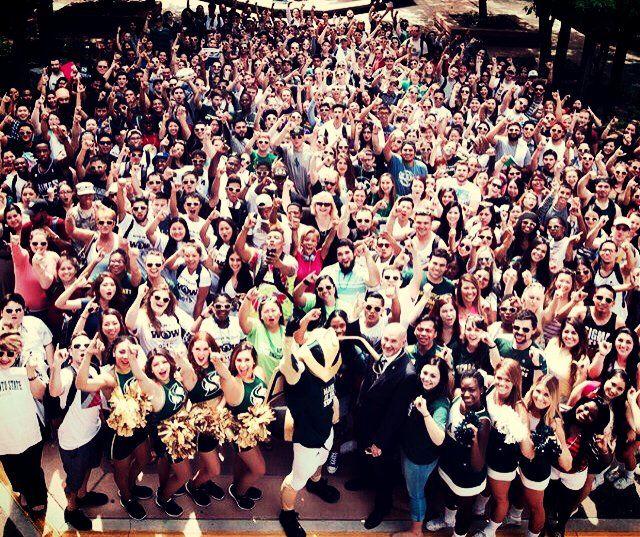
left=129, top=348, right=198, bottom=518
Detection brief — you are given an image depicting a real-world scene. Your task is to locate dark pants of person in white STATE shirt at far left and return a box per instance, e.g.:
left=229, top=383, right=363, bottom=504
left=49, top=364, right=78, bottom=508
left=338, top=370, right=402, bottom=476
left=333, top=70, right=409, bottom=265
left=0, top=442, right=47, bottom=508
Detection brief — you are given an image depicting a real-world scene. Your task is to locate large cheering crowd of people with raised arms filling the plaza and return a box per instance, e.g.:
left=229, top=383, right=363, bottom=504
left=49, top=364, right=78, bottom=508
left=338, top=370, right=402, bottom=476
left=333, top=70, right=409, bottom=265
left=0, top=2, right=640, bottom=537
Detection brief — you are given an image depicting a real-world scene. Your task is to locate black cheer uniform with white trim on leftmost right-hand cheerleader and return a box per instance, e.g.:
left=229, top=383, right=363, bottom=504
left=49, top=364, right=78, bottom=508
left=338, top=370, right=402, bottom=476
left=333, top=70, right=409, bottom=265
left=438, top=397, right=490, bottom=497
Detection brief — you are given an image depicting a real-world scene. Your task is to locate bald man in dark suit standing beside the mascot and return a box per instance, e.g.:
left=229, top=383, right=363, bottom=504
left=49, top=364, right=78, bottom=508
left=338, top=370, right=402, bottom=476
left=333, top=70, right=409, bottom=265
left=346, top=323, right=417, bottom=529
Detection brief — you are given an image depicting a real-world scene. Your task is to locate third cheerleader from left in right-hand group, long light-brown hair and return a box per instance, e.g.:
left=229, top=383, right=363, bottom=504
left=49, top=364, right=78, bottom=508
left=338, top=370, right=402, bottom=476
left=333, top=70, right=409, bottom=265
left=509, top=374, right=571, bottom=537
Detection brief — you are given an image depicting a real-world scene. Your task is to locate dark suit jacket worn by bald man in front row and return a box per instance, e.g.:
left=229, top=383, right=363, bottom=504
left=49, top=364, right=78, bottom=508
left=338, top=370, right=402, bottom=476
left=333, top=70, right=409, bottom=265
left=355, top=351, right=417, bottom=451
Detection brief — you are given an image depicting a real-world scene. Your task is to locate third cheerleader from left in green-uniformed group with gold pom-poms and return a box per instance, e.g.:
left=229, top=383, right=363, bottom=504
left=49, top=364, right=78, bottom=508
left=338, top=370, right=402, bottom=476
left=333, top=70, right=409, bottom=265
left=185, top=332, right=224, bottom=507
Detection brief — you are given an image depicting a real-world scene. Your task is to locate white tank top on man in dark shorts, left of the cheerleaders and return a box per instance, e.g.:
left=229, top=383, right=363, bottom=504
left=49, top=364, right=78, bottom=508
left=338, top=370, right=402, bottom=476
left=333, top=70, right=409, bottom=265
left=58, top=367, right=103, bottom=451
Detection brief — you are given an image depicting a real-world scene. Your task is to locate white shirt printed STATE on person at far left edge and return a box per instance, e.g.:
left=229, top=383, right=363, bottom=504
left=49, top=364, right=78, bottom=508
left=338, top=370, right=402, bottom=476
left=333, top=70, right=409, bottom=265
left=0, top=367, right=42, bottom=455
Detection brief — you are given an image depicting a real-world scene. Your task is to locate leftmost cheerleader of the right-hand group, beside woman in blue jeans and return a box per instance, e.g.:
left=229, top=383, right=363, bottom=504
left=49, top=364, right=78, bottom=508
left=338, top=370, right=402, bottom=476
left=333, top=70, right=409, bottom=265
left=426, top=369, right=491, bottom=537
